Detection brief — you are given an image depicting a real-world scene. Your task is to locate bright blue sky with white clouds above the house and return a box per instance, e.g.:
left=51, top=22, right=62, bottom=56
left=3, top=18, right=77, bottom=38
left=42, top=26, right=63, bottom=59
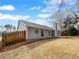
left=0, top=0, right=76, bottom=26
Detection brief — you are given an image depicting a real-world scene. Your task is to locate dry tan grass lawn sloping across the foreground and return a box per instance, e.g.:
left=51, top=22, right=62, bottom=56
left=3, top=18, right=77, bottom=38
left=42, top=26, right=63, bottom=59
left=0, top=37, right=79, bottom=59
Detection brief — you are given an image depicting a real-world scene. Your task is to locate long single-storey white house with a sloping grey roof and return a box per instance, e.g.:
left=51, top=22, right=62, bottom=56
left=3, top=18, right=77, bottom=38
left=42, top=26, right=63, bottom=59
left=17, top=20, right=54, bottom=39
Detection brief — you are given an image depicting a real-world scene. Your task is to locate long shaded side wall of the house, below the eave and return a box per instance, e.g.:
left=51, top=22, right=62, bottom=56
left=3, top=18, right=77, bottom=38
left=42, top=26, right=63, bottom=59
left=28, top=27, right=52, bottom=39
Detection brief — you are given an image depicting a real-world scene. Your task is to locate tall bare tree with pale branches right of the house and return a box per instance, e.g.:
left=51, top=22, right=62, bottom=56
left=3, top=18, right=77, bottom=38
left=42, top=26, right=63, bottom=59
left=47, top=0, right=79, bottom=35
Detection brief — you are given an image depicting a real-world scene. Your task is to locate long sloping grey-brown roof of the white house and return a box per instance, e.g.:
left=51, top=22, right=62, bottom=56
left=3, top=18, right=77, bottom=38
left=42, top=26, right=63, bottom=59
left=19, top=20, right=53, bottom=30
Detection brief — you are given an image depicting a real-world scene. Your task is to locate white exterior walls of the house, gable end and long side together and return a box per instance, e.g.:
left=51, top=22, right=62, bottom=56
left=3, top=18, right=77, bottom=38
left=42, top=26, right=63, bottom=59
left=17, top=22, right=52, bottom=39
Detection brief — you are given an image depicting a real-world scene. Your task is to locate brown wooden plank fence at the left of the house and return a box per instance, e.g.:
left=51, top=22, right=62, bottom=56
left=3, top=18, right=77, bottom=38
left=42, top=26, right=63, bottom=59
left=2, top=31, right=26, bottom=46
